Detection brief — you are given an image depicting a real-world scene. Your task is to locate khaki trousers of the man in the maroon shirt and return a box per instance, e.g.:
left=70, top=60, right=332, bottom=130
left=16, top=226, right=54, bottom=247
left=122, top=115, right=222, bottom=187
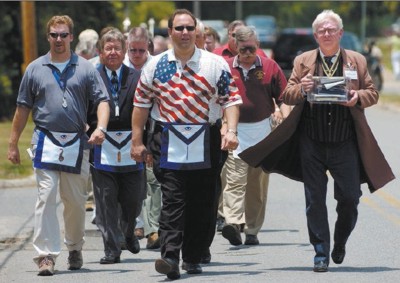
left=221, top=152, right=269, bottom=235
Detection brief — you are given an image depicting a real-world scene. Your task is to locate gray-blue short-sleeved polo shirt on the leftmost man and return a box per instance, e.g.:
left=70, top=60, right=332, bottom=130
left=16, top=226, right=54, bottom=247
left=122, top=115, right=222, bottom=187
left=17, top=52, right=109, bottom=144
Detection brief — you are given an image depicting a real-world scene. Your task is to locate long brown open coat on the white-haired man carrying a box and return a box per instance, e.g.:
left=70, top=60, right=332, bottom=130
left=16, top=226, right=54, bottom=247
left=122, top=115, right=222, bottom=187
left=239, top=49, right=395, bottom=192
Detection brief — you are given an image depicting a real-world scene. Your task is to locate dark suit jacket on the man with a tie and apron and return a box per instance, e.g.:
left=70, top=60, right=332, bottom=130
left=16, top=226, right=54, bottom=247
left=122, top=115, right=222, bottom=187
left=88, top=64, right=140, bottom=136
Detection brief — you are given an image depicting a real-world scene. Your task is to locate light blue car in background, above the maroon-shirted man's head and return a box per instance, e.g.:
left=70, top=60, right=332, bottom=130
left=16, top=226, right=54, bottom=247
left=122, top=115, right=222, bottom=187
left=245, top=15, right=277, bottom=48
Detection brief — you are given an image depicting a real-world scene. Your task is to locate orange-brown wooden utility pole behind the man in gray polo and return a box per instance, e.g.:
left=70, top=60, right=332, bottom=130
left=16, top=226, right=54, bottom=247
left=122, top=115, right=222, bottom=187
left=21, top=1, right=37, bottom=73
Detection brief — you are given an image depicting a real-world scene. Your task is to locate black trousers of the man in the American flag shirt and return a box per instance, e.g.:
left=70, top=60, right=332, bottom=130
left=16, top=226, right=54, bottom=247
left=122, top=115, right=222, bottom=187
left=150, top=125, right=221, bottom=263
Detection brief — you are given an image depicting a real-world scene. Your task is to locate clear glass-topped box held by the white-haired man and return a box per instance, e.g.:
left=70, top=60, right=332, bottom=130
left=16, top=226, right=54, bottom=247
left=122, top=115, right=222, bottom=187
left=307, top=77, right=350, bottom=103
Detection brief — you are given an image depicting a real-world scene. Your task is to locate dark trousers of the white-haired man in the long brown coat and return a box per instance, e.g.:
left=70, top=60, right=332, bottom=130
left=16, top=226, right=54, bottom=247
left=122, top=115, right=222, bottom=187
left=300, top=134, right=362, bottom=262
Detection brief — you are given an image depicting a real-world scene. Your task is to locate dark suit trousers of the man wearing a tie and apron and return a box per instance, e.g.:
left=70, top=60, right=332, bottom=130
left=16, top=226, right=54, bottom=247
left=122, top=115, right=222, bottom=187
left=91, top=167, right=146, bottom=256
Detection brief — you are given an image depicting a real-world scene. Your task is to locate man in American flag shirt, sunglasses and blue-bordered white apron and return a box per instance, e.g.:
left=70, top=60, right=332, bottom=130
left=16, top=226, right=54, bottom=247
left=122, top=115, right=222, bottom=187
left=131, top=9, right=242, bottom=280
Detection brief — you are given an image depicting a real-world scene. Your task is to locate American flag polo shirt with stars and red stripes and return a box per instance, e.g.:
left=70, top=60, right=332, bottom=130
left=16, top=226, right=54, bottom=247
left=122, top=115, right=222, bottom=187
left=134, top=48, right=242, bottom=124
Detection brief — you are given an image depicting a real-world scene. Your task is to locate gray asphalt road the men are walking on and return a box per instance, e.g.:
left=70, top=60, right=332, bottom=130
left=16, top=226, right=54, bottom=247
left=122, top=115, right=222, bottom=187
left=0, top=102, right=400, bottom=283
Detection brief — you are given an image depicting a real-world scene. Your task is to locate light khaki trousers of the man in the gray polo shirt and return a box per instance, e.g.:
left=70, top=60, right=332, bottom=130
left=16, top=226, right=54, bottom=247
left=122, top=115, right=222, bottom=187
left=33, top=150, right=89, bottom=263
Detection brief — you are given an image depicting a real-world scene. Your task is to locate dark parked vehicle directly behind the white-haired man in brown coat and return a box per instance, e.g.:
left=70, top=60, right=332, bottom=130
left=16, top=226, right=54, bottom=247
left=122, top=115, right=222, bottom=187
left=271, top=28, right=383, bottom=90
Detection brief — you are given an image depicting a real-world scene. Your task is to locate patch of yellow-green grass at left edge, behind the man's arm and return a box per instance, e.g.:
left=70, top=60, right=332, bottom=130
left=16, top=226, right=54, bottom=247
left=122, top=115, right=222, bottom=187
left=0, top=121, right=34, bottom=179
